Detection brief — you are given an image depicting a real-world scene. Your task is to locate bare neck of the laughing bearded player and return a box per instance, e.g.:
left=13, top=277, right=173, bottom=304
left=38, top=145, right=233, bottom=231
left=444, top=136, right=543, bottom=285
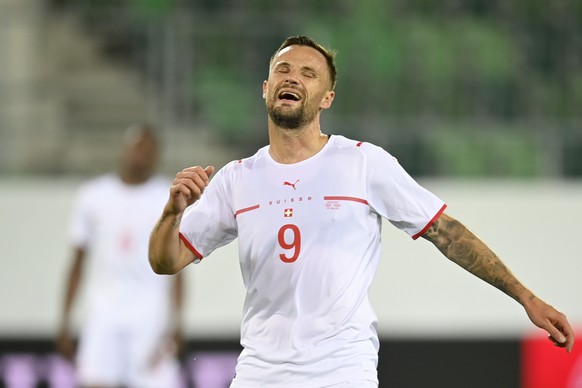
left=269, top=125, right=329, bottom=164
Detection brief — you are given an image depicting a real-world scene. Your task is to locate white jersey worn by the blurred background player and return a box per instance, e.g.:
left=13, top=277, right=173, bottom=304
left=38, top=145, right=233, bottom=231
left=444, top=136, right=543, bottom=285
left=70, top=174, right=171, bottom=327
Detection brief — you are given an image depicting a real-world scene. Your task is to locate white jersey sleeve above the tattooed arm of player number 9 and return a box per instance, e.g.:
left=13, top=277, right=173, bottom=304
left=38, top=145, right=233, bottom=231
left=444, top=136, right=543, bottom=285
left=362, top=143, right=446, bottom=239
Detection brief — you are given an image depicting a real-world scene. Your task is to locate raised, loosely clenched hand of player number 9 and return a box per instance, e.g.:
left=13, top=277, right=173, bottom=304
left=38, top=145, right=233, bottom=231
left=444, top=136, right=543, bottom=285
left=166, top=166, right=214, bottom=214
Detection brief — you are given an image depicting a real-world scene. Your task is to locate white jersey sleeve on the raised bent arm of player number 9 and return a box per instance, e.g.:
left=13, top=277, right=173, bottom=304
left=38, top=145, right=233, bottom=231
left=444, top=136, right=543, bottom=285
left=180, top=164, right=238, bottom=259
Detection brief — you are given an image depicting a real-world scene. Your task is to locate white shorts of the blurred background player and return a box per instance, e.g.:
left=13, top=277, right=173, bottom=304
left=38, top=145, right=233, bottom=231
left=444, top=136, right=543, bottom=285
left=77, top=322, right=180, bottom=388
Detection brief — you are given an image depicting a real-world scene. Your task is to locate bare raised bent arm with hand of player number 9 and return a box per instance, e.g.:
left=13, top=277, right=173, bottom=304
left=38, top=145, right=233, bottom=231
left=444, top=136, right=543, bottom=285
left=149, top=166, right=214, bottom=274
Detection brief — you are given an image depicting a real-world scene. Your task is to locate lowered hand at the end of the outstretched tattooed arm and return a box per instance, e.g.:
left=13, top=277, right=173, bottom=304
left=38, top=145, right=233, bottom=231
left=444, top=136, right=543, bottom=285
left=524, top=298, right=574, bottom=353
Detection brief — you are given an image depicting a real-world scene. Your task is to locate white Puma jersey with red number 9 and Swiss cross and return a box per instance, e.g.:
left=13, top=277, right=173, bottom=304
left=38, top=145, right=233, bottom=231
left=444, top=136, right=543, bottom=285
left=181, top=136, right=445, bottom=388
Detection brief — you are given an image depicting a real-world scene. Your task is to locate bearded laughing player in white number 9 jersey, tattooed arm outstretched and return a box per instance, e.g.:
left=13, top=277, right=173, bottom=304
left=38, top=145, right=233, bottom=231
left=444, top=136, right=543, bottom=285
left=149, top=37, right=574, bottom=388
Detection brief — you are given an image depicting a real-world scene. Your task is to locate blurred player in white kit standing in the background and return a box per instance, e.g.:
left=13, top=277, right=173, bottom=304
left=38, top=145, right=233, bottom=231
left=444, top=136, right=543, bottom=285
left=57, top=125, right=183, bottom=388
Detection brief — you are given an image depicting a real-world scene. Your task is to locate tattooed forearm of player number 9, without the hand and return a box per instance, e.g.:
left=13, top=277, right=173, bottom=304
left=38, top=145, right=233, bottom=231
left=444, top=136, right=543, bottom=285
left=422, top=214, right=522, bottom=301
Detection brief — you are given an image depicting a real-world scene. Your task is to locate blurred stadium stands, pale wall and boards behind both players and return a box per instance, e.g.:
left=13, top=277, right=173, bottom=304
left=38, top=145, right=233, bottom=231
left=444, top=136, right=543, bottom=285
left=0, top=0, right=582, bottom=388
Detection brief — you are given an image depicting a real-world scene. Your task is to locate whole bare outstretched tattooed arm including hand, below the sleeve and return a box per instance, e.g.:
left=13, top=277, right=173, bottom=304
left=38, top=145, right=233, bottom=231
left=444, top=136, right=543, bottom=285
left=422, top=214, right=574, bottom=352
